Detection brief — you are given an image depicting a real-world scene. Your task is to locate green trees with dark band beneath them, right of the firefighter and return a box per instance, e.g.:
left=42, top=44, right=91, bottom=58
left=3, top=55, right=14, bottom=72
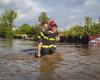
left=61, top=16, right=100, bottom=43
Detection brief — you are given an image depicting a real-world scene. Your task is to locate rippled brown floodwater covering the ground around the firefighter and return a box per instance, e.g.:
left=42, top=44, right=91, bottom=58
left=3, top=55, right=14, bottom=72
left=0, top=40, right=100, bottom=80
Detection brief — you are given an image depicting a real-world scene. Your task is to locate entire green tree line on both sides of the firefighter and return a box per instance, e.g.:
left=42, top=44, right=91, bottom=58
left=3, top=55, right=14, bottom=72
left=0, top=9, right=100, bottom=42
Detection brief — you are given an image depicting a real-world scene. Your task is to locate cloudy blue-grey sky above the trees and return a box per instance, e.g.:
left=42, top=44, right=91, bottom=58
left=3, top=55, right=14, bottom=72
left=0, top=0, right=100, bottom=30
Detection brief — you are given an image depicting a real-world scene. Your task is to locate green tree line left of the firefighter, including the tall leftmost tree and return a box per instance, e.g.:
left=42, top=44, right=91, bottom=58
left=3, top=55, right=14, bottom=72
left=0, top=9, right=49, bottom=38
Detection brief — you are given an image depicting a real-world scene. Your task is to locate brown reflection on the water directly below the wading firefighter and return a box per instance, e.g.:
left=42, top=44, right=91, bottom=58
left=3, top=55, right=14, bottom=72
left=38, top=53, right=62, bottom=80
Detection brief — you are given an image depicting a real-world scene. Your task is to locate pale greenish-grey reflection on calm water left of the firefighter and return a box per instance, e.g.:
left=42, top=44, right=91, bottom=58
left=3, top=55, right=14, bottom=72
left=0, top=39, right=35, bottom=53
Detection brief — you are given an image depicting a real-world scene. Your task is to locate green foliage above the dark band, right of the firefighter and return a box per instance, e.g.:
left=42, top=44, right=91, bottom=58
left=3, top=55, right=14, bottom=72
left=64, top=16, right=100, bottom=36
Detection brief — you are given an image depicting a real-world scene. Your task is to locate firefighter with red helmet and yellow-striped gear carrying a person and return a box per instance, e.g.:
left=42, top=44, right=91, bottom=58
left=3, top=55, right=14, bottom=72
left=36, top=20, right=59, bottom=57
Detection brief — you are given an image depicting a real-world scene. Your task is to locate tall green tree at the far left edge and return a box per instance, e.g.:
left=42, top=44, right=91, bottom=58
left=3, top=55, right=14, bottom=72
left=0, top=9, right=17, bottom=38
